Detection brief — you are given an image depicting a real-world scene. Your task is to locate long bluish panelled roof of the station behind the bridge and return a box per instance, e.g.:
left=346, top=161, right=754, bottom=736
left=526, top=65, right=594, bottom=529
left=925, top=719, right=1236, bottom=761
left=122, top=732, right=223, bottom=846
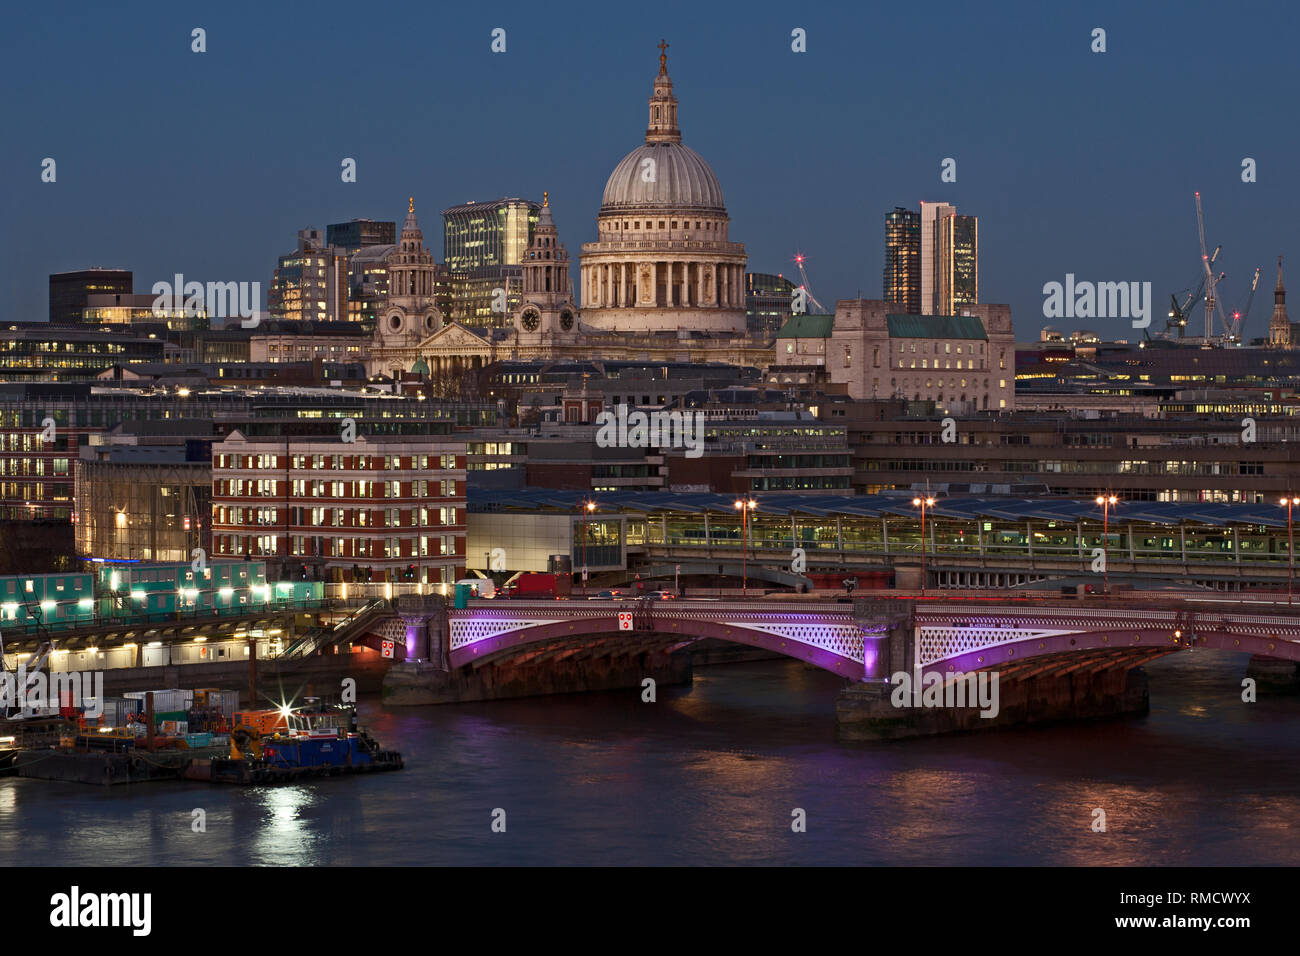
left=468, top=488, right=1287, bottom=528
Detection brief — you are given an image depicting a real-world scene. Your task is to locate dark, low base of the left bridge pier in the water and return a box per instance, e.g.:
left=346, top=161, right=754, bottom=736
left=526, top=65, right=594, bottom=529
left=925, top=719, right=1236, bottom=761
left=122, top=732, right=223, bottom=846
left=384, top=653, right=692, bottom=706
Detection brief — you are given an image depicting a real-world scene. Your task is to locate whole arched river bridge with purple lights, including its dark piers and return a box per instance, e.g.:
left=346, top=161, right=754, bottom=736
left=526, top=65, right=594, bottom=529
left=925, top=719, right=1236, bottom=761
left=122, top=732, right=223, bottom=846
left=379, top=593, right=1300, bottom=736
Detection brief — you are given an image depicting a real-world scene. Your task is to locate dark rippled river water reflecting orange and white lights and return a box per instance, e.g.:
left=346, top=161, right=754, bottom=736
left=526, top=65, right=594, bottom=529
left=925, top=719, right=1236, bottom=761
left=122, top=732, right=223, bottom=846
left=0, top=652, right=1300, bottom=865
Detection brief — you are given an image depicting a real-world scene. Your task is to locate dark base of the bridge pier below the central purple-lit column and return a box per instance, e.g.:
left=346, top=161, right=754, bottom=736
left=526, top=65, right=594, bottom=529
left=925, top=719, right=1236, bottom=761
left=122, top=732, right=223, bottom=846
left=835, top=667, right=1151, bottom=740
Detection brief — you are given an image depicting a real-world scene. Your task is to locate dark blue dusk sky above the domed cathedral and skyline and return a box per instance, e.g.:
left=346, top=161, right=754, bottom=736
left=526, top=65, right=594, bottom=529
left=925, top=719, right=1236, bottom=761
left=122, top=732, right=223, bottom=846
left=0, top=0, right=1300, bottom=339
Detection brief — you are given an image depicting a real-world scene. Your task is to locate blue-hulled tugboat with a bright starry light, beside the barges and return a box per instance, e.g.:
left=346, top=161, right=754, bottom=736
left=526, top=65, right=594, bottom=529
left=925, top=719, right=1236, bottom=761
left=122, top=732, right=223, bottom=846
left=192, top=697, right=404, bottom=783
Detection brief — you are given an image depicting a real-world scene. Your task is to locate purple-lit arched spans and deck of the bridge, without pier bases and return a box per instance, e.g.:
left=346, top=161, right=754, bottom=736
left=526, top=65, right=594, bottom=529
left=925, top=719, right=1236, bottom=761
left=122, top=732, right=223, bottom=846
left=446, top=596, right=1300, bottom=682
